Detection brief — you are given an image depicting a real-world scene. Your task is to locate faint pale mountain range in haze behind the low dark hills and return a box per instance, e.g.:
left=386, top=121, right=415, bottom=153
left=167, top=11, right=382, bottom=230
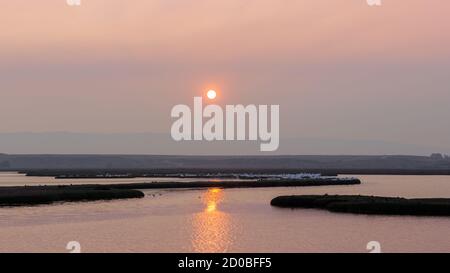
left=0, top=132, right=444, bottom=156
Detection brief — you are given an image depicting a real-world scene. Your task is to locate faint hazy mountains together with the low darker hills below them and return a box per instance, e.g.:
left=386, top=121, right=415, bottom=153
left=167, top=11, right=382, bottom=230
left=0, top=132, right=450, bottom=170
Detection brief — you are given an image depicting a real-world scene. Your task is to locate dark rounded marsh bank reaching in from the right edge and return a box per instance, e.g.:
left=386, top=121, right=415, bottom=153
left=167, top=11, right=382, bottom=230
left=270, top=195, right=450, bottom=216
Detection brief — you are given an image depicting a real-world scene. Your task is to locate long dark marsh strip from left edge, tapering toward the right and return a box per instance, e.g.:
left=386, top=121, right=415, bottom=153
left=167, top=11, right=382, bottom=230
left=0, top=179, right=361, bottom=206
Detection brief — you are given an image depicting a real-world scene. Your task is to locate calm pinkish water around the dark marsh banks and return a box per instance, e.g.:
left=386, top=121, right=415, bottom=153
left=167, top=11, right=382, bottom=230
left=0, top=174, right=450, bottom=252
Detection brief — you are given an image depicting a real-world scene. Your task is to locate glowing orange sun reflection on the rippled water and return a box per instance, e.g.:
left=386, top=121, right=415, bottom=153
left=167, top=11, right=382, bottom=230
left=192, top=188, right=232, bottom=252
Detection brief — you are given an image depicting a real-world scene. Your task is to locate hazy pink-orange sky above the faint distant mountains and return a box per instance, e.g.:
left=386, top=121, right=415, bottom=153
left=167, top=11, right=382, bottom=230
left=0, top=0, right=450, bottom=153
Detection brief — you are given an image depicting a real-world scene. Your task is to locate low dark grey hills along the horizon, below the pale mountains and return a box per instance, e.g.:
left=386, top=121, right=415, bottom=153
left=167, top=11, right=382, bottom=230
left=0, top=155, right=450, bottom=170
